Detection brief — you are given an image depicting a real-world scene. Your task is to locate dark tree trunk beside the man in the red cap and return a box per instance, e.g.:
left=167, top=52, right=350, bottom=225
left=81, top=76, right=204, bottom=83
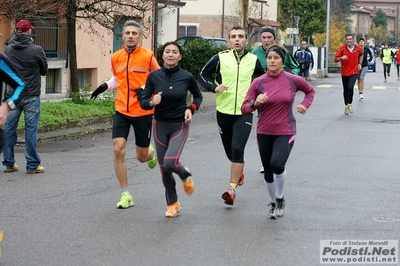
left=67, top=0, right=80, bottom=103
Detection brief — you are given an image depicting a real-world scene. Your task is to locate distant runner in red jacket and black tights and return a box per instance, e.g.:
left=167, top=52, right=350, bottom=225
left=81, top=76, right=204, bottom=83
left=334, top=33, right=364, bottom=115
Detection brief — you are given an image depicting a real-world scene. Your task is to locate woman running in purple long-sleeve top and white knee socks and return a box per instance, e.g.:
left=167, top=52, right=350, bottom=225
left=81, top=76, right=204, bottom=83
left=242, top=45, right=315, bottom=219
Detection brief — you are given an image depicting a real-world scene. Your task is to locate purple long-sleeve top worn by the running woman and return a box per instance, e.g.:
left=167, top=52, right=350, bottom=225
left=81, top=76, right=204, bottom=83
left=242, top=71, right=315, bottom=136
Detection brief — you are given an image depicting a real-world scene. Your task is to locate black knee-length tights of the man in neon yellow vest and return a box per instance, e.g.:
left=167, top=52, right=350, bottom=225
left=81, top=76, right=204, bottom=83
left=217, top=111, right=253, bottom=163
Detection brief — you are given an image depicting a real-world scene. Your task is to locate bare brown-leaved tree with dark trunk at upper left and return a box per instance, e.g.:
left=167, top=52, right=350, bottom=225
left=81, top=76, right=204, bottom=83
left=0, top=0, right=155, bottom=100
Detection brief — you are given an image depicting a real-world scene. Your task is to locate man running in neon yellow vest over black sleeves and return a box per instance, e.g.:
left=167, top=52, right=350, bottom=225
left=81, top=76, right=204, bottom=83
left=198, top=27, right=265, bottom=205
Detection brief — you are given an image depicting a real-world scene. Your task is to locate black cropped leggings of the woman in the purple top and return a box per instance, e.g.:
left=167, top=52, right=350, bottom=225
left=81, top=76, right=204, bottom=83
left=257, top=134, right=294, bottom=183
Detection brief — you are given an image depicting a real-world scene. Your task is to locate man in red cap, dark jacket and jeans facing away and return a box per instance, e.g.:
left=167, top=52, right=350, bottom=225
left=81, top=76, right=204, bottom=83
left=3, top=20, right=48, bottom=174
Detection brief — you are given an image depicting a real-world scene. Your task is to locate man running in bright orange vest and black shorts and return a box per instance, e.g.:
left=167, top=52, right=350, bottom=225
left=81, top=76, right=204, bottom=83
left=91, top=20, right=160, bottom=209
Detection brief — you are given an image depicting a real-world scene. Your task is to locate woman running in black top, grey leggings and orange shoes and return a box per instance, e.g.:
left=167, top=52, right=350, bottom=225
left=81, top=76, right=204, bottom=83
left=140, top=42, right=203, bottom=217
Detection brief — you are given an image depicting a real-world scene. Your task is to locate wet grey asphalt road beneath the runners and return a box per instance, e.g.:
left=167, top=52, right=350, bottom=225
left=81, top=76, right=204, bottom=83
left=0, top=60, right=400, bottom=266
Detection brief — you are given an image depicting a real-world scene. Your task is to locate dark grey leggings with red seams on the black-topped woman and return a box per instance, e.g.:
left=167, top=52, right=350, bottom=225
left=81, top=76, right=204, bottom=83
left=153, top=121, right=190, bottom=205
